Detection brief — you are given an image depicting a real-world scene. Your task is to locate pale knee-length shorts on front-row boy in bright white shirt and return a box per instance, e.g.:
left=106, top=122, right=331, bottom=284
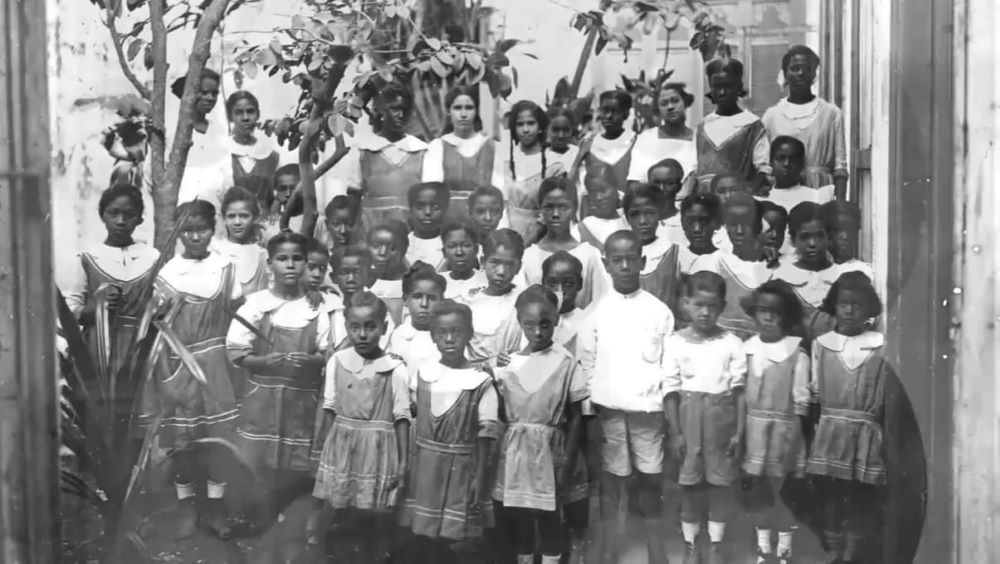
left=596, top=406, right=667, bottom=477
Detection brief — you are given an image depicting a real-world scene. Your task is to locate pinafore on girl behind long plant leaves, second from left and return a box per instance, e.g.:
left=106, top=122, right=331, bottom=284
left=154, top=264, right=239, bottom=448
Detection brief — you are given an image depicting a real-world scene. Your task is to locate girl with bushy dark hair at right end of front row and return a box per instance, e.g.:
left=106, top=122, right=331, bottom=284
left=806, top=272, right=901, bottom=562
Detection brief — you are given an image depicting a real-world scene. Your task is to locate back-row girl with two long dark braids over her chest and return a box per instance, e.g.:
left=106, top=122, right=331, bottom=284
left=504, top=100, right=566, bottom=244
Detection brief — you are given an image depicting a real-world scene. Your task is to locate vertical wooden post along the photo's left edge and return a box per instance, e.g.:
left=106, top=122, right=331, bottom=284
left=0, top=0, right=60, bottom=564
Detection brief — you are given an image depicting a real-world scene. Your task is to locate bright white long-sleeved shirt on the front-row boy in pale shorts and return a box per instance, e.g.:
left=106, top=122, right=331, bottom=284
left=577, top=289, right=674, bottom=413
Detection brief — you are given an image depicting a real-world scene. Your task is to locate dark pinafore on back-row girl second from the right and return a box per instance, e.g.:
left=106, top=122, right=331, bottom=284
left=695, top=120, right=766, bottom=192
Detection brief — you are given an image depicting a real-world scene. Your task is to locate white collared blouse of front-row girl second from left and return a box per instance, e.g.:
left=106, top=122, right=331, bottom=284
left=410, top=362, right=500, bottom=429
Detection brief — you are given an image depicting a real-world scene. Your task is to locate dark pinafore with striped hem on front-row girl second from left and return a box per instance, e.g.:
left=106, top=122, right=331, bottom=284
left=399, top=376, right=495, bottom=541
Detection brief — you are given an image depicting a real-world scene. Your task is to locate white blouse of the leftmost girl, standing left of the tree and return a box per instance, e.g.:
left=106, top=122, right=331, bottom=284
left=65, top=243, right=160, bottom=314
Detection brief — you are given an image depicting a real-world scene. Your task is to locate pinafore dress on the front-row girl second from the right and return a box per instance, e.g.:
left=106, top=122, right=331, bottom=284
left=743, top=337, right=806, bottom=478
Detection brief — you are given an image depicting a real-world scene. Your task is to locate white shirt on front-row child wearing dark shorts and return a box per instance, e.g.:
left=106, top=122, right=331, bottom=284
left=664, top=331, right=747, bottom=395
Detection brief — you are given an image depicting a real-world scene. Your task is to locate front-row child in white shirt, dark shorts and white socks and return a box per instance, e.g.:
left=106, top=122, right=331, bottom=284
left=663, top=271, right=747, bottom=562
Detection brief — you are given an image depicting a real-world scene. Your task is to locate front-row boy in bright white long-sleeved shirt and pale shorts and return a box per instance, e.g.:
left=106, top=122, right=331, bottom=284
left=577, top=230, right=674, bottom=562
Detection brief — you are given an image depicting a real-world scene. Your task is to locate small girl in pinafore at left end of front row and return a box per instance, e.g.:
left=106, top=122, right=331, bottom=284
left=307, top=292, right=410, bottom=562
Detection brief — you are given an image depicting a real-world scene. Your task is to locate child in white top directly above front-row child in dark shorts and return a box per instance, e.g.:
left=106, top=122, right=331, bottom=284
left=678, top=192, right=723, bottom=274
